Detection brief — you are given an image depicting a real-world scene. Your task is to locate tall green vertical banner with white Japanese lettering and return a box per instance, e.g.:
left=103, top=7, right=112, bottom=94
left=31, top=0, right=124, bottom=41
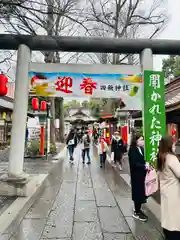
left=144, top=71, right=166, bottom=162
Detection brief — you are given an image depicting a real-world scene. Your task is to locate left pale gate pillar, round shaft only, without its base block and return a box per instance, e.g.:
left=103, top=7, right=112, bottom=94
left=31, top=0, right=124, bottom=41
left=8, top=45, right=31, bottom=178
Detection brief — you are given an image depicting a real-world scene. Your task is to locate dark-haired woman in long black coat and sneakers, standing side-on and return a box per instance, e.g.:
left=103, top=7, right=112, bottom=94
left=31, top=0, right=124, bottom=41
left=128, top=135, right=147, bottom=222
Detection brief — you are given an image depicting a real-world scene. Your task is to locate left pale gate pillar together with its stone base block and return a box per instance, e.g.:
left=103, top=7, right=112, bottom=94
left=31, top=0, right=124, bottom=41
left=0, top=44, right=35, bottom=196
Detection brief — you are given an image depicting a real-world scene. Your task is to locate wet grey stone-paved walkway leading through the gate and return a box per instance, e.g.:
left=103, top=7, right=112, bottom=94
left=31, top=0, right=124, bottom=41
left=0, top=148, right=163, bottom=240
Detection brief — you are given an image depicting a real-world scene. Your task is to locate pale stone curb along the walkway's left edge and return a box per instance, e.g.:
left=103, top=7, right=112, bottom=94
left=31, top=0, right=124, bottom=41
left=0, top=147, right=66, bottom=236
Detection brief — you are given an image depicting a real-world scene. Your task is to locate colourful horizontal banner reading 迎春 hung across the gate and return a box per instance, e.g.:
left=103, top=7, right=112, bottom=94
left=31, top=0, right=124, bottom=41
left=29, top=72, right=143, bottom=110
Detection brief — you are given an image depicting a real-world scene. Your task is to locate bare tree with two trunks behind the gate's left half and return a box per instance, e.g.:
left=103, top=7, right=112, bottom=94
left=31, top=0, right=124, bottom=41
left=0, top=0, right=87, bottom=143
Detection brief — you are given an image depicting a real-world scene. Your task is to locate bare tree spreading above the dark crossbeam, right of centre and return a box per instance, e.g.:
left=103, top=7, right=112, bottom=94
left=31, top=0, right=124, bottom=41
left=86, top=0, right=167, bottom=64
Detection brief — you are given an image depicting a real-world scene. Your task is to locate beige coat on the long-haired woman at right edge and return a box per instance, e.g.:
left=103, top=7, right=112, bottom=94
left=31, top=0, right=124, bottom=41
left=159, top=154, right=180, bottom=231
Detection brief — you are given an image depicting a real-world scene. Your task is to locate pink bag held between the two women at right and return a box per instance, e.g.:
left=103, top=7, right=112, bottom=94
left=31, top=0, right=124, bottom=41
left=145, top=167, right=159, bottom=197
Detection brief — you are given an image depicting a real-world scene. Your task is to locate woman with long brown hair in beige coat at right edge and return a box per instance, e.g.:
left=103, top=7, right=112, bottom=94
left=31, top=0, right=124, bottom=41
left=157, top=136, right=180, bottom=240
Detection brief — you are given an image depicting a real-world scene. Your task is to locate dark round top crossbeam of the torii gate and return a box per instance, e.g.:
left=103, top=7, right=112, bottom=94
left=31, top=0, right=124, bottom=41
left=0, top=34, right=180, bottom=55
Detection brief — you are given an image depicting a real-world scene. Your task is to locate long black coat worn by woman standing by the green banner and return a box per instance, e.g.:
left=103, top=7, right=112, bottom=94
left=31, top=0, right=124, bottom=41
left=128, top=146, right=146, bottom=203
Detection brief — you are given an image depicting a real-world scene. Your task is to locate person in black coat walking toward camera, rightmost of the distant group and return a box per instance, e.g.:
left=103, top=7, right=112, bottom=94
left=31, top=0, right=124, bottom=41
left=111, top=132, right=124, bottom=170
